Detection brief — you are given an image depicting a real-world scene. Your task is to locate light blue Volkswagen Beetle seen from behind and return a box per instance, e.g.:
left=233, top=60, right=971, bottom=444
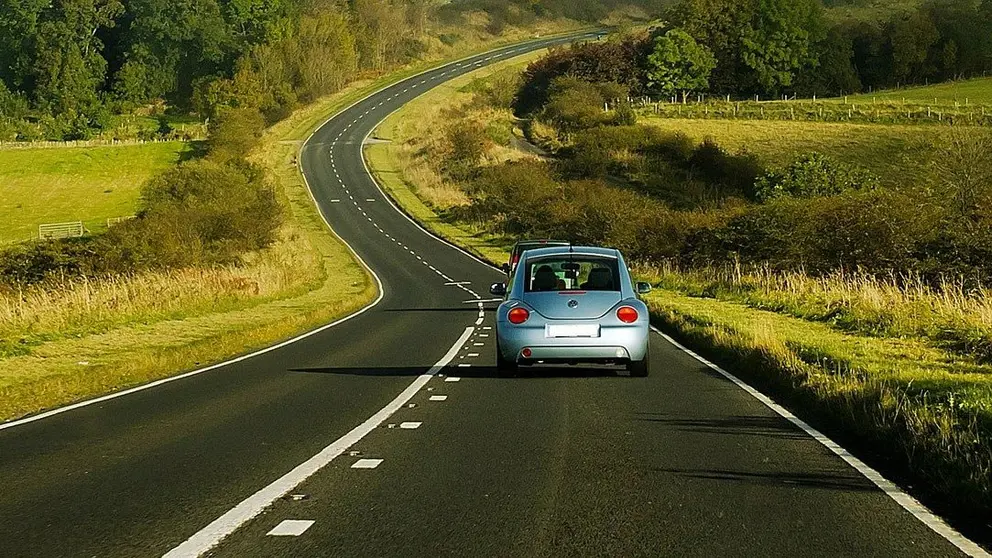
left=490, top=246, right=651, bottom=376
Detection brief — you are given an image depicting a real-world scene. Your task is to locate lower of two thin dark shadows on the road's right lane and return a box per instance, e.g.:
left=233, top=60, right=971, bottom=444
left=652, top=468, right=878, bottom=492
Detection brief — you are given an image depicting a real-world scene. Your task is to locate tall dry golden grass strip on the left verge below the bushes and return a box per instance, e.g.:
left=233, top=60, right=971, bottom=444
left=0, top=234, right=321, bottom=358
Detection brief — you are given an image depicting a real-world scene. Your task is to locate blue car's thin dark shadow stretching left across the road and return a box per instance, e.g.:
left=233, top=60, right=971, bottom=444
left=289, top=366, right=622, bottom=381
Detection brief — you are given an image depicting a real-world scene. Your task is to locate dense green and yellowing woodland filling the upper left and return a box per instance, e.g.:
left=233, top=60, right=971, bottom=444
left=0, top=0, right=668, bottom=141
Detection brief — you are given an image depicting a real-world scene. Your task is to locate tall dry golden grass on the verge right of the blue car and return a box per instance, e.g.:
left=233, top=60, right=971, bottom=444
left=642, top=264, right=992, bottom=363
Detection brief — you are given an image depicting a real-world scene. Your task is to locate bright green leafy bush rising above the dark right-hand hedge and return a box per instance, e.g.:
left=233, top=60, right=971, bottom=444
left=755, top=152, right=878, bottom=201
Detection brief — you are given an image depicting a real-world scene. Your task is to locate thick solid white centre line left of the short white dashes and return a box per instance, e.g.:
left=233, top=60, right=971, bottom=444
left=163, top=327, right=474, bottom=558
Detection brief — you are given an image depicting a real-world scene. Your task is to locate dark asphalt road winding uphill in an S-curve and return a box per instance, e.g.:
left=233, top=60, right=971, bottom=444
left=0, top=31, right=980, bottom=558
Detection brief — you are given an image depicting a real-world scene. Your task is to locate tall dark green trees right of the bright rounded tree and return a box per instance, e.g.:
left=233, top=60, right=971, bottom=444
left=669, top=0, right=992, bottom=95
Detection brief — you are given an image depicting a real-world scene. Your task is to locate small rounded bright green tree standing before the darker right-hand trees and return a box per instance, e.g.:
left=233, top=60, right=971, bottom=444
left=647, top=29, right=716, bottom=103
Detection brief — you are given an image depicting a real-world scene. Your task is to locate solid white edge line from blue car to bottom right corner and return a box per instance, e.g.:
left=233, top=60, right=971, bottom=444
left=651, top=326, right=992, bottom=558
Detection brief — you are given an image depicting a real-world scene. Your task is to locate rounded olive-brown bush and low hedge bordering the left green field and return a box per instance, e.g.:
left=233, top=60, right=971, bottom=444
left=0, top=160, right=281, bottom=284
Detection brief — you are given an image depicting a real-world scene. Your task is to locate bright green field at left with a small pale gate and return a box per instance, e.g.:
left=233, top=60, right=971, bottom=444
left=0, top=142, right=191, bottom=243
